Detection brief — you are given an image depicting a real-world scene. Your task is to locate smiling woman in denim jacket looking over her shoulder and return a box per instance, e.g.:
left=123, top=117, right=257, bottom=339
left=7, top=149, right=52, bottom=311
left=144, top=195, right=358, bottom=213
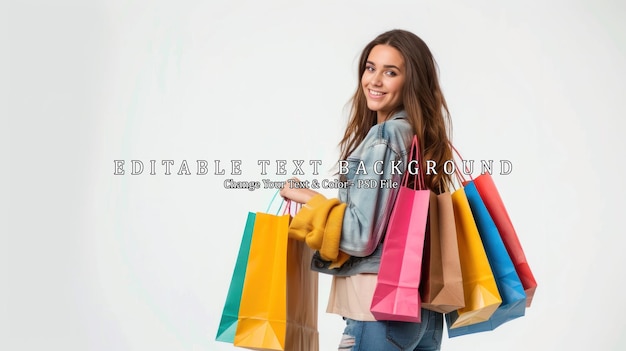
left=281, top=30, right=452, bottom=351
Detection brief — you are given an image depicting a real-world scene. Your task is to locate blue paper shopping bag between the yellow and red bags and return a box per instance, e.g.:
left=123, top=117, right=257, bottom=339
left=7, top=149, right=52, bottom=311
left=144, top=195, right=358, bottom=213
left=448, top=181, right=526, bottom=337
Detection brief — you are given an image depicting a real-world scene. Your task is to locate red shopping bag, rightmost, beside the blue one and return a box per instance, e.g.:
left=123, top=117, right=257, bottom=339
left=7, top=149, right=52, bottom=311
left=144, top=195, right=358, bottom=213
left=474, top=173, right=537, bottom=307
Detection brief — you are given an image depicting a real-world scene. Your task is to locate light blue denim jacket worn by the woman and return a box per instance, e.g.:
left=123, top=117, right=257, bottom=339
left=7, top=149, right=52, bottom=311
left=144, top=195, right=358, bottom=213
left=311, top=111, right=414, bottom=276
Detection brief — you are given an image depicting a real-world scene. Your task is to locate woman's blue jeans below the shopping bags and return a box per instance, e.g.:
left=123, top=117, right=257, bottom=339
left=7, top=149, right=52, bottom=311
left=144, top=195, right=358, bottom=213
left=338, top=309, right=443, bottom=351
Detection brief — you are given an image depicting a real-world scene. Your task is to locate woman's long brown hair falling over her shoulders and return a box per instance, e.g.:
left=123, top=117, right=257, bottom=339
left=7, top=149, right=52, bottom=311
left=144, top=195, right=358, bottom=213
left=339, top=29, right=452, bottom=192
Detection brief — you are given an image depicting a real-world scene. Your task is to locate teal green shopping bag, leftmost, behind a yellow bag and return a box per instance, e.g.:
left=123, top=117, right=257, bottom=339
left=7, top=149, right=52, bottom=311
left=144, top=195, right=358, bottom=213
left=215, top=212, right=256, bottom=343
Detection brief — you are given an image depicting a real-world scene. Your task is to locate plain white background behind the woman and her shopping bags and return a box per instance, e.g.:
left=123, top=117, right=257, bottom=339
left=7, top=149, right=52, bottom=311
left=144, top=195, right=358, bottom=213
left=0, top=0, right=626, bottom=351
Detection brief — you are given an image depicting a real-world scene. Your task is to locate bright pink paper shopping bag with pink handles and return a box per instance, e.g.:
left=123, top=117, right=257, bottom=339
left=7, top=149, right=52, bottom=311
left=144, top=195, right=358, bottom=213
left=370, top=136, right=430, bottom=322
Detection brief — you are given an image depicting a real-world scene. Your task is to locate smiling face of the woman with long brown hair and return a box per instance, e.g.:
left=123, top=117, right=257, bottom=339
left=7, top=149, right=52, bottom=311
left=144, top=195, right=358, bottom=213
left=361, top=45, right=405, bottom=123
